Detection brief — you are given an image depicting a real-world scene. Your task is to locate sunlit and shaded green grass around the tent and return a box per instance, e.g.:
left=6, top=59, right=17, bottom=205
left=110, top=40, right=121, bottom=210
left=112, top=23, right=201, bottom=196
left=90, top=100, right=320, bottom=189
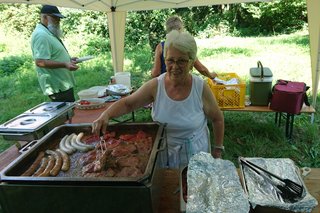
left=0, top=28, right=320, bottom=167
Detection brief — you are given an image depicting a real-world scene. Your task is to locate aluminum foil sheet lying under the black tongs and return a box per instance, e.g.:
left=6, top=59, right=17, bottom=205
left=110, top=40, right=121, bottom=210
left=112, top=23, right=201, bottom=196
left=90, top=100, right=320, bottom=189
left=240, top=158, right=318, bottom=212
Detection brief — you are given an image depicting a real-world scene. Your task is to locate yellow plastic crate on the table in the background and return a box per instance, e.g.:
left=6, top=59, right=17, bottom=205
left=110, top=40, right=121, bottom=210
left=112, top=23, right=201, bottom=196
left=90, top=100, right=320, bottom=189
left=207, top=73, right=246, bottom=108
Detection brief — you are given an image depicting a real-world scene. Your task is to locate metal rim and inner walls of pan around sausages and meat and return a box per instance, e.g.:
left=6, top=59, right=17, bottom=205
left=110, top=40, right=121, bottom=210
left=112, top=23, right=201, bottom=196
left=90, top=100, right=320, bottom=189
left=1, top=123, right=163, bottom=183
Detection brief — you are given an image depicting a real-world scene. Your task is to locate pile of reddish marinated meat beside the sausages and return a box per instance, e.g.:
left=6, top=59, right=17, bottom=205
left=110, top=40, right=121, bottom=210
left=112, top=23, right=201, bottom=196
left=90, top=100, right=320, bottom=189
left=78, top=131, right=153, bottom=177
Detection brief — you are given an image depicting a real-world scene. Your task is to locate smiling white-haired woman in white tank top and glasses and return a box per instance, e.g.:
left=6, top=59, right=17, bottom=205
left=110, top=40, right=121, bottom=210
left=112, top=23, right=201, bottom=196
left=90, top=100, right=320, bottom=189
left=92, top=30, right=224, bottom=168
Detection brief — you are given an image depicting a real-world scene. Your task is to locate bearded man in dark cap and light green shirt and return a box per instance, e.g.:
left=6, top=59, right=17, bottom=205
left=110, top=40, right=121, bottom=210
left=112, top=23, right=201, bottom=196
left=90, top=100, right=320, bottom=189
left=31, top=5, right=79, bottom=102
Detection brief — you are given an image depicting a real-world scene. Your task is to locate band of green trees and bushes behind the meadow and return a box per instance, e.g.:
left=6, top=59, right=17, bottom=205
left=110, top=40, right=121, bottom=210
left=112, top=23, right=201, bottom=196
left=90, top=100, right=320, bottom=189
left=0, top=0, right=307, bottom=51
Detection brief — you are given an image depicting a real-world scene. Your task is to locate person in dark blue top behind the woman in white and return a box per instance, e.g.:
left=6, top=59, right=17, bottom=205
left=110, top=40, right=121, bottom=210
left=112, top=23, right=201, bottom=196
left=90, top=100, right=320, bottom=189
left=151, top=16, right=217, bottom=78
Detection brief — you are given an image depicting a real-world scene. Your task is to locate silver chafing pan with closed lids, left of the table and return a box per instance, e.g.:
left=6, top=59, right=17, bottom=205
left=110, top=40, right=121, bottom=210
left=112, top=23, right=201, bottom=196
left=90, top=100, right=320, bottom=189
left=0, top=102, right=74, bottom=141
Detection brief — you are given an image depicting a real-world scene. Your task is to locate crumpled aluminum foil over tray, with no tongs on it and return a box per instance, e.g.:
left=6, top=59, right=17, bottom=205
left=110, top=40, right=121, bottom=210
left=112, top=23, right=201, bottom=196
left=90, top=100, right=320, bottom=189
left=186, top=152, right=250, bottom=213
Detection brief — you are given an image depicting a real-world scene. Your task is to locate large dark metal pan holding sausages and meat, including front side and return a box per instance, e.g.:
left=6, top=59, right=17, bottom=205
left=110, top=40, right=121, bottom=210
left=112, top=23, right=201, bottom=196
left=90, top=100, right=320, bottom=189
left=0, top=123, right=164, bottom=213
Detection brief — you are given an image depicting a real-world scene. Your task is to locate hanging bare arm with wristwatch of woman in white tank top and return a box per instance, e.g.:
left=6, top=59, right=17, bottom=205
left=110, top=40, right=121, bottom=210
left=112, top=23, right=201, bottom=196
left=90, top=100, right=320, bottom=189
left=202, top=83, right=224, bottom=158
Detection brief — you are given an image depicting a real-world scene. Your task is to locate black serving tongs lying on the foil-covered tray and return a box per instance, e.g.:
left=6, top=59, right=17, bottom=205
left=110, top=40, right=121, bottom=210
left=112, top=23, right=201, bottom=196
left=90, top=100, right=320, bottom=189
left=240, top=157, right=303, bottom=202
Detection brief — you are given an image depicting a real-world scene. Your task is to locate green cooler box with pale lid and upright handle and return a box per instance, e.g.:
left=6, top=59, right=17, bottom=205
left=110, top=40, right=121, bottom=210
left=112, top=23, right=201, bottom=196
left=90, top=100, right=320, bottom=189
left=250, top=61, right=272, bottom=106
